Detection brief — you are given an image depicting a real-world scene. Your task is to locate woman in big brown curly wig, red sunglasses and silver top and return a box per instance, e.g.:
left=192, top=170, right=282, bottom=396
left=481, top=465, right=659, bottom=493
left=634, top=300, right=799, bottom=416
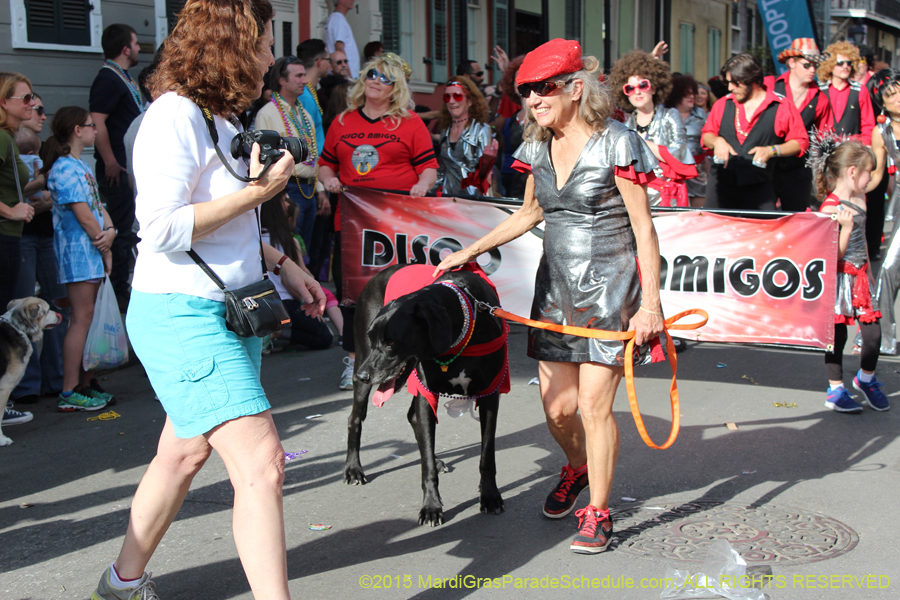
left=609, top=50, right=695, bottom=206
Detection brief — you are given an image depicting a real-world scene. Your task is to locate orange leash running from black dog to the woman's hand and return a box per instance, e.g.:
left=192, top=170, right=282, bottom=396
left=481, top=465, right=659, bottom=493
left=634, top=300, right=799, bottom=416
left=479, top=303, right=709, bottom=450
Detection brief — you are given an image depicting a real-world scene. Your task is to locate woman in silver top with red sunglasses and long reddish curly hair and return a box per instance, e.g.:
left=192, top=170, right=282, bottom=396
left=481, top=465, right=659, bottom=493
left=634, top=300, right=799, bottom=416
left=435, top=77, right=497, bottom=196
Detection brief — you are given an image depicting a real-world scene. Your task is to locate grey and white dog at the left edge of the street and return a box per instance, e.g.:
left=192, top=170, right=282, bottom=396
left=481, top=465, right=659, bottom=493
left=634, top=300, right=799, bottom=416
left=0, top=298, right=62, bottom=446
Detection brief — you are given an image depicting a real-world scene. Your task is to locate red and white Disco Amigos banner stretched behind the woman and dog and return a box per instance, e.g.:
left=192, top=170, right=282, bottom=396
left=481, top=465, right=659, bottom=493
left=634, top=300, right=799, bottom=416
left=341, top=188, right=838, bottom=350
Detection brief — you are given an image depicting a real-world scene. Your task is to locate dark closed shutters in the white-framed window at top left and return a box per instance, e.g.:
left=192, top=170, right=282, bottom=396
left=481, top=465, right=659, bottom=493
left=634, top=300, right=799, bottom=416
left=25, top=0, right=91, bottom=46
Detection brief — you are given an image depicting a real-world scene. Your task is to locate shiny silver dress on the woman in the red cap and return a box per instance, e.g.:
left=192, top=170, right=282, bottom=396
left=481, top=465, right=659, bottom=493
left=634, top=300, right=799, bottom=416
left=515, top=119, right=657, bottom=365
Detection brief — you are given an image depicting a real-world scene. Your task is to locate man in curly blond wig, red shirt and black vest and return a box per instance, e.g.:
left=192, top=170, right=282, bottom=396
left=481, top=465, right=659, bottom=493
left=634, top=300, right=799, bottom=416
left=817, top=41, right=875, bottom=144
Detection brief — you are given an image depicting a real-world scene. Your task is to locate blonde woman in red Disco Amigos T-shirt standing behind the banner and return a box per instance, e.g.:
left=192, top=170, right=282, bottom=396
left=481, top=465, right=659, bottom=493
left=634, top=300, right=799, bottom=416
left=319, top=52, right=438, bottom=390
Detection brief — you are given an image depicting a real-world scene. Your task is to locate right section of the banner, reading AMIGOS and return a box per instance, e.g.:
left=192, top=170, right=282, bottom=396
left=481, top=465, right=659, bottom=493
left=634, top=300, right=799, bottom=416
left=653, top=212, right=838, bottom=350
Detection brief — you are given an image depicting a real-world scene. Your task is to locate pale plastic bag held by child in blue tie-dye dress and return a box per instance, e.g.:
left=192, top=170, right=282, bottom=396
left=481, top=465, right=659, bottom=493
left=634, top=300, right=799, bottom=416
left=81, top=276, right=128, bottom=371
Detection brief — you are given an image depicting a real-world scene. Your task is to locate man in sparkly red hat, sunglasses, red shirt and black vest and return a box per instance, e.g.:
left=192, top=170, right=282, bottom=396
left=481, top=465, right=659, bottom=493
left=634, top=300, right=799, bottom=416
left=766, top=38, right=832, bottom=212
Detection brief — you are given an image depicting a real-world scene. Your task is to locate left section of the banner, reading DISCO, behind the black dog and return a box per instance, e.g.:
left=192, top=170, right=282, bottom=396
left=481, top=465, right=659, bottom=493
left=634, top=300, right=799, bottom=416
left=340, top=188, right=543, bottom=315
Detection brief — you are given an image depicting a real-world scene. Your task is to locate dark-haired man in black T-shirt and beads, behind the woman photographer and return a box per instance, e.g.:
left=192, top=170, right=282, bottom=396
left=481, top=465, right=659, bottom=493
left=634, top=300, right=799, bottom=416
left=89, top=23, right=145, bottom=312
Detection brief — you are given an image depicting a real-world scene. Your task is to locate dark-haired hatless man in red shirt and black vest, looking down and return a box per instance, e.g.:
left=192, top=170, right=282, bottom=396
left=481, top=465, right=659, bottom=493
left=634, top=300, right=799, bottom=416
left=702, top=54, right=809, bottom=210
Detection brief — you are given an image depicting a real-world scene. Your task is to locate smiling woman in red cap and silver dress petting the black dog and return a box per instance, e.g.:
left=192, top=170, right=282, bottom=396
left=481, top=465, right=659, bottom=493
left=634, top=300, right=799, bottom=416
left=435, top=39, right=663, bottom=554
